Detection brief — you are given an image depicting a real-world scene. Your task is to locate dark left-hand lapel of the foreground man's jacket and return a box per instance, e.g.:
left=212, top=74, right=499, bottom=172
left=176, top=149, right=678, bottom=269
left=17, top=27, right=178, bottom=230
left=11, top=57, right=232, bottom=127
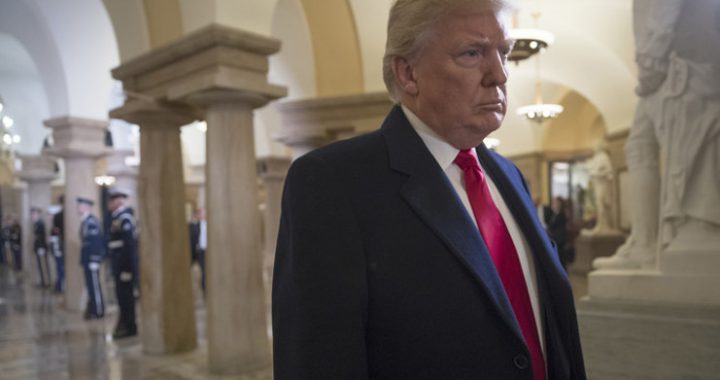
left=383, top=107, right=522, bottom=339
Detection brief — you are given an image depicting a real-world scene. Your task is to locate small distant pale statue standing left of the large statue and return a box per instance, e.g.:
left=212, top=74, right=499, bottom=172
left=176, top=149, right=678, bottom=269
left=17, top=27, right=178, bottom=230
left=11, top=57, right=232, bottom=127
left=581, top=142, right=619, bottom=236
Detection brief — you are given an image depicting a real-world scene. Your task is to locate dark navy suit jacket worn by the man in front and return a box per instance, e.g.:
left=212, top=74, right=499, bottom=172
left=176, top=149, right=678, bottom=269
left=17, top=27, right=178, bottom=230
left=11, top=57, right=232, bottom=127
left=272, top=107, right=585, bottom=380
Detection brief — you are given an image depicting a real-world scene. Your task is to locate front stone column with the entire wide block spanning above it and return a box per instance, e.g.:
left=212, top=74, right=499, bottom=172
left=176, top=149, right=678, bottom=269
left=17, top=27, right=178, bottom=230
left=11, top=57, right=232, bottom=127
left=113, top=24, right=286, bottom=373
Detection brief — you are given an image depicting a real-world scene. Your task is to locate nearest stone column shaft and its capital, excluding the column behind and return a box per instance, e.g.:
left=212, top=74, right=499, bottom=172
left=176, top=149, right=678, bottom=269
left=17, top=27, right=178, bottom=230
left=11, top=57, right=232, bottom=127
left=175, top=27, right=286, bottom=373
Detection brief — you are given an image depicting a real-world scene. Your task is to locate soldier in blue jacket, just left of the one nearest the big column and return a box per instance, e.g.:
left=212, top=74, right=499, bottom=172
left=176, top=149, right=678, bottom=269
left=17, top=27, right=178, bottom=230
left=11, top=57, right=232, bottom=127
left=77, top=197, right=105, bottom=319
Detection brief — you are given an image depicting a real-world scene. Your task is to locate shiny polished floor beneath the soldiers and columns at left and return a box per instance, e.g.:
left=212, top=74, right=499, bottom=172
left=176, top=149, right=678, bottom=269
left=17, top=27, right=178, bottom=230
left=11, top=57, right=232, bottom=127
left=0, top=267, right=272, bottom=380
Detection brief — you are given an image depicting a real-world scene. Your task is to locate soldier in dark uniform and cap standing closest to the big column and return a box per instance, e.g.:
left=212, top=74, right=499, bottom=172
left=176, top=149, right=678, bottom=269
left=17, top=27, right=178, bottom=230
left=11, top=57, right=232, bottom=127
left=108, top=189, right=138, bottom=339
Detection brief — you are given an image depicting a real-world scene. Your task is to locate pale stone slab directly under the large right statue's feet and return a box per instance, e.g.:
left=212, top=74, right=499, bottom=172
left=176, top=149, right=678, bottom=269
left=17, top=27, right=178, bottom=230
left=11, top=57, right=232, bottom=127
left=588, top=269, right=720, bottom=307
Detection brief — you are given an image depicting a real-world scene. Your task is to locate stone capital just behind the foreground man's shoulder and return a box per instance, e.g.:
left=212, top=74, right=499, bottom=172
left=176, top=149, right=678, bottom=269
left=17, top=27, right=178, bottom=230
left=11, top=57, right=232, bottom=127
left=275, top=92, right=393, bottom=160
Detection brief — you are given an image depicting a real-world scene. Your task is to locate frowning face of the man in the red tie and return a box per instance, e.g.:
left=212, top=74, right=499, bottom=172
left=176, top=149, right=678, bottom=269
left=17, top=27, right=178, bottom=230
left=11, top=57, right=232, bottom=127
left=406, top=7, right=512, bottom=149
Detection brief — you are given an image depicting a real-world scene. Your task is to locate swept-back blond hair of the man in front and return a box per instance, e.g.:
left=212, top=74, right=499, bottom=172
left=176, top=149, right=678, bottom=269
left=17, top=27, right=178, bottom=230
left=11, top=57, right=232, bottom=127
left=383, top=0, right=514, bottom=102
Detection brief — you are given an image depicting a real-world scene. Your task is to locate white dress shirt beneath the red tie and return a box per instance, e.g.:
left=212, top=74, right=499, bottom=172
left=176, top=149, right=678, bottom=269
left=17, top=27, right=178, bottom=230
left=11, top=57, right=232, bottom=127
left=402, top=106, right=545, bottom=353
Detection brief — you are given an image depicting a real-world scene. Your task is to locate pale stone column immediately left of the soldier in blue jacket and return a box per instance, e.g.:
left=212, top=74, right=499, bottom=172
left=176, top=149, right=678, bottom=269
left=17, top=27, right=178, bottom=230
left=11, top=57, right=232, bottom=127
left=45, top=116, right=110, bottom=311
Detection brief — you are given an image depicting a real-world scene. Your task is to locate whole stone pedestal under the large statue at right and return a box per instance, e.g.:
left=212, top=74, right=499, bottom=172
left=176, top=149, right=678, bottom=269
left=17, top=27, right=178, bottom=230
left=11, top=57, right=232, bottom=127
left=578, top=245, right=720, bottom=379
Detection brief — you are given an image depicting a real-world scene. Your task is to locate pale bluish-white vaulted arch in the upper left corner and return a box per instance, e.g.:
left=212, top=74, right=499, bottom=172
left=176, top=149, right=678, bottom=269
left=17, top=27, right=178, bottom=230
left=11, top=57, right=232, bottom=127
left=0, top=0, right=119, bottom=153
